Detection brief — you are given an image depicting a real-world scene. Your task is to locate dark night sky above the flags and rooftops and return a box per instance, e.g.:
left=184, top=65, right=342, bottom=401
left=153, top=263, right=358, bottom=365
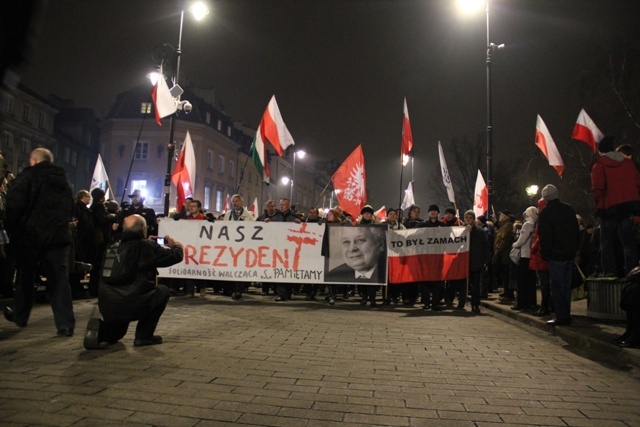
left=17, top=0, right=640, bottom=208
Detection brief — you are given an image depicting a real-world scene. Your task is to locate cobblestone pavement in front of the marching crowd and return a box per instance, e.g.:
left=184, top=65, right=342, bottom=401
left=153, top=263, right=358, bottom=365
left=0, top=293, right=640, bottom=427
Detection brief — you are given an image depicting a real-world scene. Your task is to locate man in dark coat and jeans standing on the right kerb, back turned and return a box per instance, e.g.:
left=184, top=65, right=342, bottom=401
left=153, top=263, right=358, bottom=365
left=538, top=184, right=580, bottom=326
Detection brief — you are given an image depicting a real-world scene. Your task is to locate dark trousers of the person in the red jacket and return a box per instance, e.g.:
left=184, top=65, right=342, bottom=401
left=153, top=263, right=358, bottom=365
left=600, top=217, right=638, bottom=275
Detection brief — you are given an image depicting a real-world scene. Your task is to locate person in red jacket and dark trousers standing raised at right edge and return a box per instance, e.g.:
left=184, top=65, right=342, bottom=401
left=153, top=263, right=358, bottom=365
left=591, top=136, right=640, bottom=279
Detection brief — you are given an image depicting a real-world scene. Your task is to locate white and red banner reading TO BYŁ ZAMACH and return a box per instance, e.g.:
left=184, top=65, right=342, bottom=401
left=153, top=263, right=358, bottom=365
left=387, top=227, right=469, bottom=284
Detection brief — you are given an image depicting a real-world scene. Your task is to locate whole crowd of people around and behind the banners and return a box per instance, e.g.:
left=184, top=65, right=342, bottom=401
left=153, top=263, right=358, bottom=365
left=0, top=137, right=640, bottom=349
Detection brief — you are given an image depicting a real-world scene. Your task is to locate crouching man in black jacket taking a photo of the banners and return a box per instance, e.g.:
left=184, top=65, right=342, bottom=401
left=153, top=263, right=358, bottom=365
left=84, top=215, right=183, bottom=350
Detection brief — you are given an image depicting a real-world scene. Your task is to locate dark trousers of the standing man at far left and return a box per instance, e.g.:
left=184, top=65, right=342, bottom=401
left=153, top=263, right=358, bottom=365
left=13, top=246, right=76, bottom=330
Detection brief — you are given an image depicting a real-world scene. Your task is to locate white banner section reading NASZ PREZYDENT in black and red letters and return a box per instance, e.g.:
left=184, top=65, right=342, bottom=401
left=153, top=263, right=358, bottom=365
left=158, top=219, right=325, bottom=283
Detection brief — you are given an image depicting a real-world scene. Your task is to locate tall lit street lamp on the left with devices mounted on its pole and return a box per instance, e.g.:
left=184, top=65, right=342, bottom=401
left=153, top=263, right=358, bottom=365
left=153, top=2, right=209, bottom=216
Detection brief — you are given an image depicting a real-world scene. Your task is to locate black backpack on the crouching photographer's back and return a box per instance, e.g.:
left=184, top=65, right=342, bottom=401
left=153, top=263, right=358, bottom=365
left=102, top=241, right=140, bottom=286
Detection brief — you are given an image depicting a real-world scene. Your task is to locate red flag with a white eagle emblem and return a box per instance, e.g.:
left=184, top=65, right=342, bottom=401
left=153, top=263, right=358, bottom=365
left=331, top=145, right=367, bottom=219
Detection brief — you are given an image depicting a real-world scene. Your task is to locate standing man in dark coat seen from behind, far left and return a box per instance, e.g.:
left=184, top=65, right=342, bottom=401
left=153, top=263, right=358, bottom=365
left=4, top=148, right=76, bottom=337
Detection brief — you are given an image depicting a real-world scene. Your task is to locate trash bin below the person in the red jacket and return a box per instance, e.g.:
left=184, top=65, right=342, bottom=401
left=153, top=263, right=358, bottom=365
left=586, top=279, right=627, bottom=321
